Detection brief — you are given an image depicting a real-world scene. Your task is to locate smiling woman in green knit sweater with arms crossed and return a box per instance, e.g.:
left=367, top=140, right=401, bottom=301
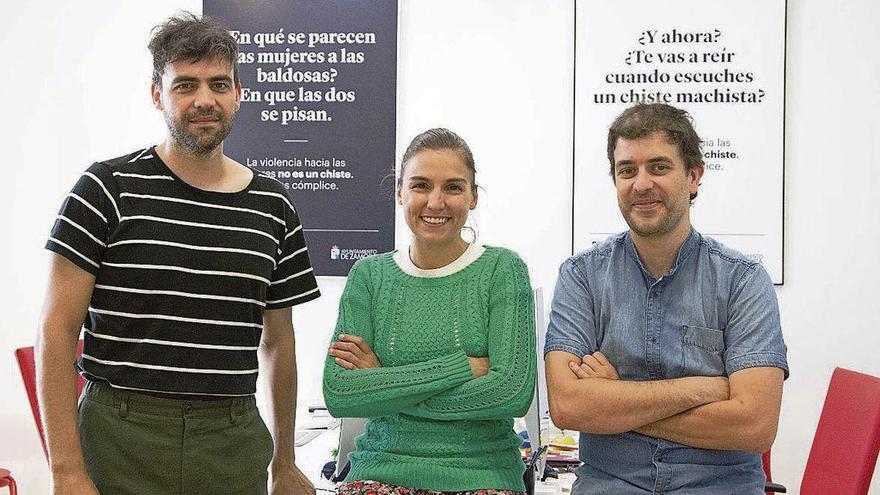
left=324, top=129, right=536, bottom=495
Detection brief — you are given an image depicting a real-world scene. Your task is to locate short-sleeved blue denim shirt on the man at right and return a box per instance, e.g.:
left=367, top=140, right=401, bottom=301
left=544, top=229, right=788, bottom=495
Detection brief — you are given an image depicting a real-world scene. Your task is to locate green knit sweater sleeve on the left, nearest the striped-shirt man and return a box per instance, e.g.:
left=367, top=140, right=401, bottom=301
left=324, top=259, right=473, bottom=418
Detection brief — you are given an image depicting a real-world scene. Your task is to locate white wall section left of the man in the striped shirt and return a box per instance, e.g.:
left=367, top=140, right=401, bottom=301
left=0, top=0, right=201, bottom=494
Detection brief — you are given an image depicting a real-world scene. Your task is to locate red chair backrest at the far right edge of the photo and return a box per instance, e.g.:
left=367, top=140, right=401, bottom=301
left=800, top=368, right=880, bottom=495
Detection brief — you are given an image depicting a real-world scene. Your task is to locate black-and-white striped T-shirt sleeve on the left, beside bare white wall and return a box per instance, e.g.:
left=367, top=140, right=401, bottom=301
left=46, top=163, right=119, bottom=275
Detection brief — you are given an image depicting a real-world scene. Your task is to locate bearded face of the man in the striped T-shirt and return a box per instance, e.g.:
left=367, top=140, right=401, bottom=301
left=152, top=59, right=241, bottom=156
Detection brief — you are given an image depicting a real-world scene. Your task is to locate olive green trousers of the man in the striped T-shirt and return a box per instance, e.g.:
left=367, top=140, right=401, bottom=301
left=78, top=381, right=273, bottom=495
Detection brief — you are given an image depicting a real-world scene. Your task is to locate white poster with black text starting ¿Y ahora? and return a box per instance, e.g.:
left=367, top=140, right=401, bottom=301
left=573, top=0, right=785, bottom=284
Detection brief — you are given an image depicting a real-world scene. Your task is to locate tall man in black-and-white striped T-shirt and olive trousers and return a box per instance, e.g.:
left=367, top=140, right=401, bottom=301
left=37, top=14, right=319, bottom=495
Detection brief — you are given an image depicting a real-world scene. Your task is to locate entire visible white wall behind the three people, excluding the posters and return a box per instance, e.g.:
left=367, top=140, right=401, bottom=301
left=0, top=0, right=880, bottom=494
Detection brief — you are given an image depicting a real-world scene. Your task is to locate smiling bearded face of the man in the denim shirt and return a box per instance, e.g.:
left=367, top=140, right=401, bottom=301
left=614, top=132, right=703, bottom=238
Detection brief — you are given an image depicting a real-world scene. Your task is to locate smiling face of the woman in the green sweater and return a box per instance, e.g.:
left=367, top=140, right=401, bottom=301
left=397, top=149, right=477, bottom=251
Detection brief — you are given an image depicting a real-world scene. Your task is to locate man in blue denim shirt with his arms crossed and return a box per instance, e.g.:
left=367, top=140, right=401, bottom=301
left=544, top=104, right=788, bottom=495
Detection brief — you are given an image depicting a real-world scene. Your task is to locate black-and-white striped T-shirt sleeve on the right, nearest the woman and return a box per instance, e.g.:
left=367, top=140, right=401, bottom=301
left=266, top=188, right=321, bottom=309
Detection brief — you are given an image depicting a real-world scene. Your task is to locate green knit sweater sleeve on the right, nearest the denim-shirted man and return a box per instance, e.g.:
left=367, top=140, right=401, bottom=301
left=404, top=252, right=537, bottom=420
